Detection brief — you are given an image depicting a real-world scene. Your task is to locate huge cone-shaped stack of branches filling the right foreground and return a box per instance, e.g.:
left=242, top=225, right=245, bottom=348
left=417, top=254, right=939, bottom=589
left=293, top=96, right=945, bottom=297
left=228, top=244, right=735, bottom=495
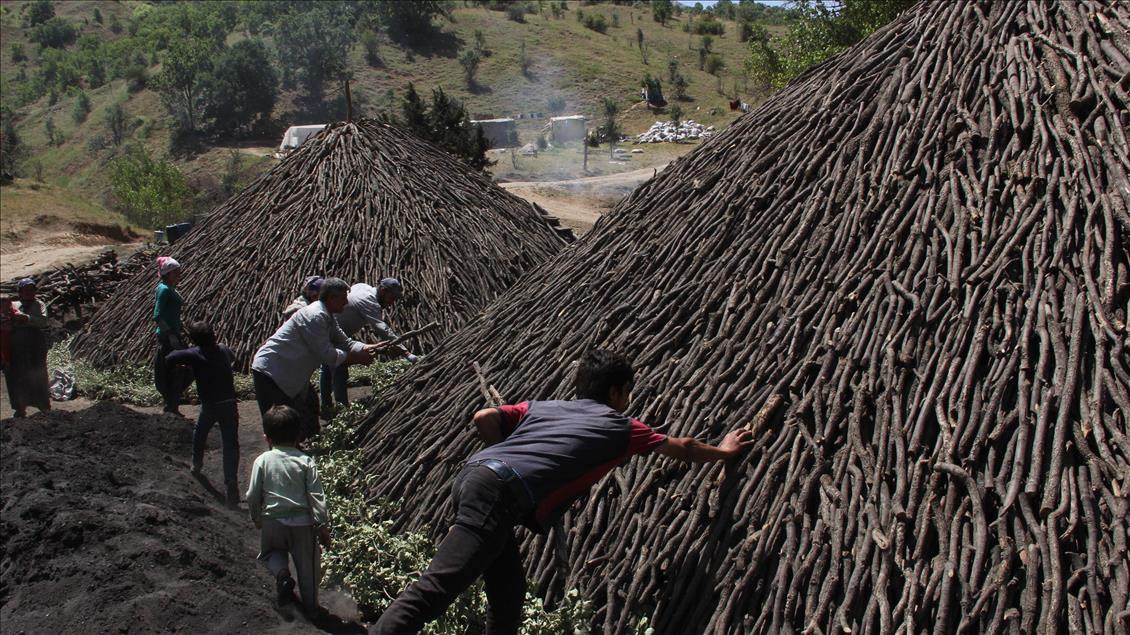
left=358, top=0, right=1130, bottom=634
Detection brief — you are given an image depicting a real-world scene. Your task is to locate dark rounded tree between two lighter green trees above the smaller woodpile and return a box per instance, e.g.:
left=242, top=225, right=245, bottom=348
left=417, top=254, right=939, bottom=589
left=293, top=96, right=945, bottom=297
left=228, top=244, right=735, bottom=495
left=202, top=38, right=279, bottom=132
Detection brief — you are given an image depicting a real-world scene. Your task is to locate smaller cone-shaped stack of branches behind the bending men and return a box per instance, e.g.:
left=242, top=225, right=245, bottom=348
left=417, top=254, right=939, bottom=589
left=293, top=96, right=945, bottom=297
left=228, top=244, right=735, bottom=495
left=75, top=121, right=573, bottom=369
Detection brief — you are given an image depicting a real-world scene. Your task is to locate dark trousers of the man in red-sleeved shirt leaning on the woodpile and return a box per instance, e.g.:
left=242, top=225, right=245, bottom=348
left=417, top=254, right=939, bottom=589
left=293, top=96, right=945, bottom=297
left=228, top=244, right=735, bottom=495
left=370, top=466, right=525, bottom=635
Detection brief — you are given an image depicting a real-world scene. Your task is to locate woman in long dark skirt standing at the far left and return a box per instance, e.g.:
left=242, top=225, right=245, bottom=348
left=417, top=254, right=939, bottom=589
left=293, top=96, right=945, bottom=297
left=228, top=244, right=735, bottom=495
left=6, top=278, right=51, bottom=417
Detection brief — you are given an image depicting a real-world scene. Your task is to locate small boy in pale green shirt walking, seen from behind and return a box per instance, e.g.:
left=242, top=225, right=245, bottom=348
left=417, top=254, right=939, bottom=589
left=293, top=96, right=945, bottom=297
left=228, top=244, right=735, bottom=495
left=247, top=406, right=330, bottom=612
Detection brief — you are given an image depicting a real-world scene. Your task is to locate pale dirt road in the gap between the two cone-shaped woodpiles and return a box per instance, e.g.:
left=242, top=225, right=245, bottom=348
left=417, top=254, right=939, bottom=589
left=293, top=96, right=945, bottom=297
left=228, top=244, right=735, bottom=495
left=499, top=164, right=667, bottom=234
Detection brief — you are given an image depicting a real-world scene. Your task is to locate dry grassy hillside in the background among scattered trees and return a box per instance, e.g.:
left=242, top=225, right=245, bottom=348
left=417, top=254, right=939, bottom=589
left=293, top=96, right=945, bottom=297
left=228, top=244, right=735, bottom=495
left=0, top=0, right=774, bottom=229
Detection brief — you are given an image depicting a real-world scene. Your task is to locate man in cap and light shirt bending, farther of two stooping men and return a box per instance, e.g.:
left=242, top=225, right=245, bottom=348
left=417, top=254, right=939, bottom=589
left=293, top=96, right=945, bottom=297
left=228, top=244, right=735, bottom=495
left=321, top=278, right=419, bottom=410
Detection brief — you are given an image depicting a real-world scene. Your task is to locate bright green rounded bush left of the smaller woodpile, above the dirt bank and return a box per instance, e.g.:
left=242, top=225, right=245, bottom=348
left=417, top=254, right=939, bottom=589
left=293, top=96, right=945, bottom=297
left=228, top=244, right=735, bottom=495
left=110, top=145, right=192, bottom=227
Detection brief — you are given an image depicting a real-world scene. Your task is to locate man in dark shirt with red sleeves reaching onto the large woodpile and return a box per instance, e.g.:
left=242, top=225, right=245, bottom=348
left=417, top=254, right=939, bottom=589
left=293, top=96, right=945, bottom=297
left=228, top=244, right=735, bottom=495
left=372, top=350, right=751, bottom=635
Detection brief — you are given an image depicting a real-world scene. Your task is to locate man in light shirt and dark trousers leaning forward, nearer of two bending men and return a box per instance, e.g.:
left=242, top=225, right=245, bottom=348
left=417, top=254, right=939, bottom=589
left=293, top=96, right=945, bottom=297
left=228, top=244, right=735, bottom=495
left=251, top=278, right=385, bottom=436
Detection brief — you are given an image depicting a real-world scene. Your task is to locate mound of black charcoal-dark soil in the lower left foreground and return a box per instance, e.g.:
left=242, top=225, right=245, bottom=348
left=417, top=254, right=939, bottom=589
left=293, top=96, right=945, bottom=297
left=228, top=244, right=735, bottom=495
left=0, top=377, right=367, bottom=634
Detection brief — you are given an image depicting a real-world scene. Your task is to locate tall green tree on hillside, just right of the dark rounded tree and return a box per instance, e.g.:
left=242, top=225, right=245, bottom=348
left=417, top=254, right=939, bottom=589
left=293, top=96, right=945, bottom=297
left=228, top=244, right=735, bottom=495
left=273, top=2, right=352, bottom=103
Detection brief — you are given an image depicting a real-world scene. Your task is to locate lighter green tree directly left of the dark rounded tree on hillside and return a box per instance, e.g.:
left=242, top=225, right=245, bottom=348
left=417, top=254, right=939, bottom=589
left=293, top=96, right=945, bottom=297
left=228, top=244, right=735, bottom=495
left=153, top=37, right=216, bottom=132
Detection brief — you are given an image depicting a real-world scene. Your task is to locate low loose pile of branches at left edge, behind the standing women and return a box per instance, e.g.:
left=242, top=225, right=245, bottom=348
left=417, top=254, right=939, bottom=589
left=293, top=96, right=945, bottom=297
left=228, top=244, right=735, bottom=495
left=0, top=249, right=156, bottom=320
